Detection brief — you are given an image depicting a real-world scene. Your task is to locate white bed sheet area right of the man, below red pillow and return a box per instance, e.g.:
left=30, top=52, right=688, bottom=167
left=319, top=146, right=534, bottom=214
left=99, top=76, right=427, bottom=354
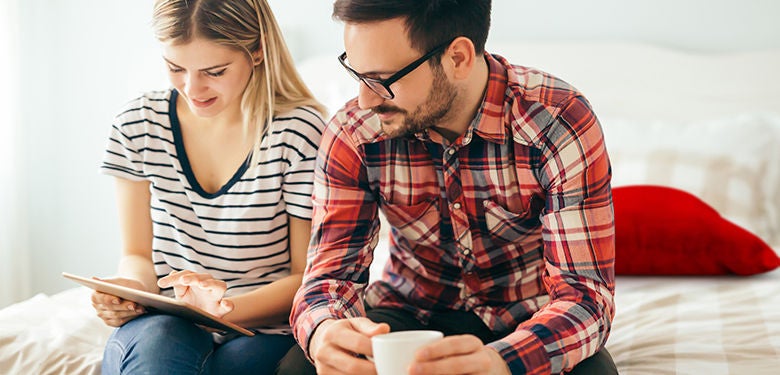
left=607, top=269, right=780, bottom=375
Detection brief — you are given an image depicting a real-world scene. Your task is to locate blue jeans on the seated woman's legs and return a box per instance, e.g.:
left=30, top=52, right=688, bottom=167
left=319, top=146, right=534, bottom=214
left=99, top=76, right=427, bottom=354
left=101, top=314, right=295, bottom=375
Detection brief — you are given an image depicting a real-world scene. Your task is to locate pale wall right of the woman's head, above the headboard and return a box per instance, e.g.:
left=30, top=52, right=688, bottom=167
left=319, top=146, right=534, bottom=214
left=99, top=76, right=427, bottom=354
left=269, top=0, right=780, bottom=59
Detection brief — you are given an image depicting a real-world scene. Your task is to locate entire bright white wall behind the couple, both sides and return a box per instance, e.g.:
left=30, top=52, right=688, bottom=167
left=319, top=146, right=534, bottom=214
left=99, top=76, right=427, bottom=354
left=0, top=0, right=780, bottom=308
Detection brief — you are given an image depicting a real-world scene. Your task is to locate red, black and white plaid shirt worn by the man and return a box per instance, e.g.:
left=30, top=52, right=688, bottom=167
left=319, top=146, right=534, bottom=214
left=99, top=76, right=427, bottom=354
left=291, top=54, right=614, bottom=374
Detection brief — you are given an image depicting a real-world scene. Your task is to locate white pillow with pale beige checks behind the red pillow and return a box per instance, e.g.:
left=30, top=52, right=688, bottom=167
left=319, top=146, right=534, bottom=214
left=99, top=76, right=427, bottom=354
left=601, top=113, right=780, bottom=246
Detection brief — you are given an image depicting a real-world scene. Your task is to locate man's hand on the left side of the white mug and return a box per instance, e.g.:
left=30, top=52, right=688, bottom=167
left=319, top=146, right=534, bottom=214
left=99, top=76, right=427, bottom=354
left=309, top=318, right=390, bottom=375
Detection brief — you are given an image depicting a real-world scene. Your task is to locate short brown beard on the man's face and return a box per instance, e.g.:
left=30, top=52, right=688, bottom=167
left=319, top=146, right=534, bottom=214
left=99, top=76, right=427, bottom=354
left=372, top=65, right=458, bottom=138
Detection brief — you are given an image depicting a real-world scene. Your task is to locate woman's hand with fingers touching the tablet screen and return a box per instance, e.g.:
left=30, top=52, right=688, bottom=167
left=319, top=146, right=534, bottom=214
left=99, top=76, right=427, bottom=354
left=157, top=271, right=233, bottom=317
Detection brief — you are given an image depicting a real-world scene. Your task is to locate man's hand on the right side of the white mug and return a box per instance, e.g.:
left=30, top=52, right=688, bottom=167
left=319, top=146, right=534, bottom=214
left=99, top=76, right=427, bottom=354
left=409, top=335, right=511, bottom=375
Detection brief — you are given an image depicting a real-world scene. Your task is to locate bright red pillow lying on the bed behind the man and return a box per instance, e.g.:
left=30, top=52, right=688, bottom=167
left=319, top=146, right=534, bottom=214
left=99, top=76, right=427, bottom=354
left=612, top=185, right=780, bottom=275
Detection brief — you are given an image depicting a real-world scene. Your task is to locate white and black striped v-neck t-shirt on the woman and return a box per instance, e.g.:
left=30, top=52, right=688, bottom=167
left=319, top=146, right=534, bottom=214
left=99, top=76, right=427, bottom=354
left=101, top=90, right=325, bottom=332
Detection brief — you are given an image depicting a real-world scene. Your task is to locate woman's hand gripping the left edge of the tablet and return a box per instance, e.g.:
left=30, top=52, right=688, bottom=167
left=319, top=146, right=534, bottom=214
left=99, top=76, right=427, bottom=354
left=92, top=278, right=146, bottom=327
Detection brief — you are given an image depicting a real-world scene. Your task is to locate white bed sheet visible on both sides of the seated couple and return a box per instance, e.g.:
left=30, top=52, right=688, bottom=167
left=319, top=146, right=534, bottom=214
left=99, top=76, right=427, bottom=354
left=0, top=269, right=780, bottom=375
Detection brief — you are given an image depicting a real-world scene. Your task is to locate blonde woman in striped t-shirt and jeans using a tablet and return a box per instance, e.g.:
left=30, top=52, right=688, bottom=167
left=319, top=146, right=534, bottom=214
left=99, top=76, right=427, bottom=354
left=92, top=0, right=324, bottom=374
